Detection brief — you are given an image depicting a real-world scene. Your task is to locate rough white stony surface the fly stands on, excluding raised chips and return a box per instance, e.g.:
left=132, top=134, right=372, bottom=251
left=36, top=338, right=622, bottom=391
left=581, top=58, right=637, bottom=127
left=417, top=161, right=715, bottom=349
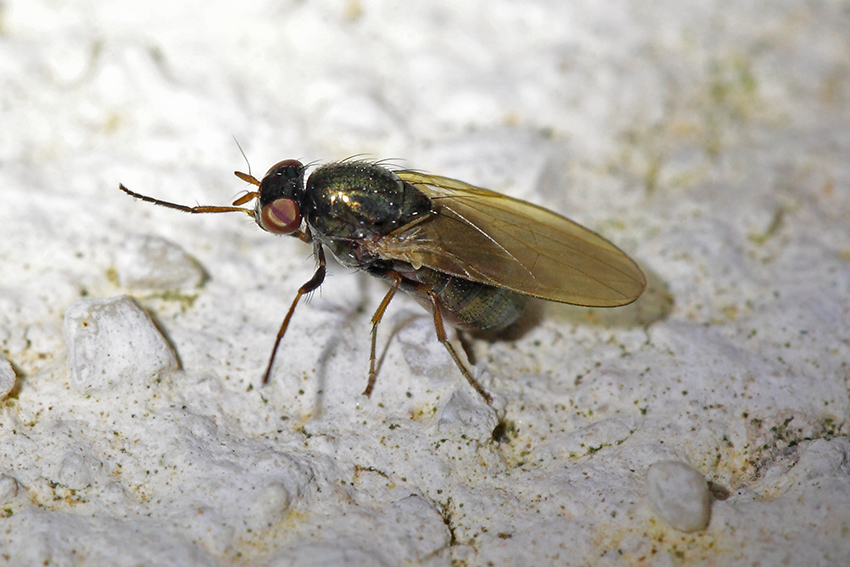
left=0, top=0, right=850, bottom=566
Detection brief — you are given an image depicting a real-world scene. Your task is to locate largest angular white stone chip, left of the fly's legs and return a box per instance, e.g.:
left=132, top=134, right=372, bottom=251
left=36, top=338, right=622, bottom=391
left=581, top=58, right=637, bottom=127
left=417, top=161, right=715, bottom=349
left=62, top=296, right=178, bottom=390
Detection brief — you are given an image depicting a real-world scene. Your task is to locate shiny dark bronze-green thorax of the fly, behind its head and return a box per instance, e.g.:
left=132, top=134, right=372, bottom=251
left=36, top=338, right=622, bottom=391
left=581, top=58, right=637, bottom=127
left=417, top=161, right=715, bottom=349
left=302, top=162, right=432, bottom=240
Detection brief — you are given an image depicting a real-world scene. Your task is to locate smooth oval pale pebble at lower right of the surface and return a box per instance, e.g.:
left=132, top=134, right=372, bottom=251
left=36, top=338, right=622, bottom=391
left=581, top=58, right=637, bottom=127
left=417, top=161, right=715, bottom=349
left=646, top=461, right=711, bottom=533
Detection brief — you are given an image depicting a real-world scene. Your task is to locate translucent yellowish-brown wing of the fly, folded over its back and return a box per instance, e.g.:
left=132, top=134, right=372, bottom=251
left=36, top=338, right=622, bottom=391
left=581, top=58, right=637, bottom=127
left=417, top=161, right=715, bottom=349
left=380, top=171, right=646, bottom=307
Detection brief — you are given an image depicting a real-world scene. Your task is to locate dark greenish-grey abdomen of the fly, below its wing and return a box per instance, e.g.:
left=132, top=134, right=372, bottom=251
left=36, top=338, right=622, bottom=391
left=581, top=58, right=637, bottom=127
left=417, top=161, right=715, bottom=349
left=402, top=268, right=527, bottom=331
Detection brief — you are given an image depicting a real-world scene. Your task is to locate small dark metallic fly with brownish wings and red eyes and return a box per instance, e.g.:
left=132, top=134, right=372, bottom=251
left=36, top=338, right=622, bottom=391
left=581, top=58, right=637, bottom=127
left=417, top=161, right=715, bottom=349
left=120, top=159, right=646, bottom=402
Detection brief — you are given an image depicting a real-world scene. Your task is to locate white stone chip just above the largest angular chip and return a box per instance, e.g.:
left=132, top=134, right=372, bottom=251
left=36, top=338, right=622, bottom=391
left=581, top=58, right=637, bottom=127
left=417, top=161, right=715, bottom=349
left=115, top=235, right=206, bottom=291
